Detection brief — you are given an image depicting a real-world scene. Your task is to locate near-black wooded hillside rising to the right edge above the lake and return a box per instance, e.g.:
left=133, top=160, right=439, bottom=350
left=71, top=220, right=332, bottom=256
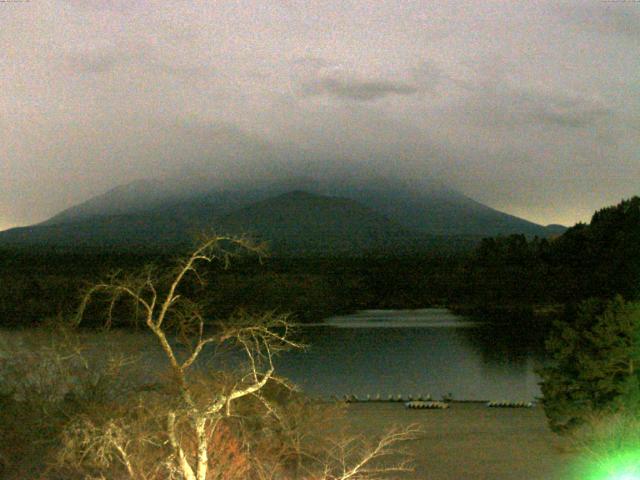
left=456, top=197, right=640, bottom=316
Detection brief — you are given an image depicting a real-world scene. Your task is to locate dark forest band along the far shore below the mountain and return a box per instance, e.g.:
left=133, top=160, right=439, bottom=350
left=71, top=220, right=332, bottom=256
left=0, top=246, right=467, bottom=326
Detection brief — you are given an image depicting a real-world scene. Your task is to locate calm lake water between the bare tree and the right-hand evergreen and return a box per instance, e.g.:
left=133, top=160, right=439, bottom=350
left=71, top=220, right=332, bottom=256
left=278, top=309, right=542, bottom=401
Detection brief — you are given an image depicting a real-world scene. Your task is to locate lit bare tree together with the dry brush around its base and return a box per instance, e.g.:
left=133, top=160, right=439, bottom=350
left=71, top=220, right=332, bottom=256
left=65, top=236, right=417, bottom=480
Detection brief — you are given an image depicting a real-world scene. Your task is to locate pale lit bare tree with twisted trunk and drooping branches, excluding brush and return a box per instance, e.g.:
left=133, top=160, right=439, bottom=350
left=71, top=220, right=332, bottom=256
left=73, top=236, right=299, bottom=480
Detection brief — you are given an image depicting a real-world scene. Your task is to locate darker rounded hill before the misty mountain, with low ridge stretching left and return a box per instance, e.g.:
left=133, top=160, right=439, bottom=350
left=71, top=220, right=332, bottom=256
left=0, top=191, right=440, bottom=254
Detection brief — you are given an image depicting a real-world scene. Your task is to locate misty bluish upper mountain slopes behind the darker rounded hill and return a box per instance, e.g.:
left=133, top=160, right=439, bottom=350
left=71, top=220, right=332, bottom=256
left=37, top=178, right=564, bottom=237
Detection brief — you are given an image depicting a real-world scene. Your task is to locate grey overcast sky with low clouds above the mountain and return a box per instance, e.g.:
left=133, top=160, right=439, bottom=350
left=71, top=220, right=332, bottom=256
left=0, top=0, right=640, bottom=229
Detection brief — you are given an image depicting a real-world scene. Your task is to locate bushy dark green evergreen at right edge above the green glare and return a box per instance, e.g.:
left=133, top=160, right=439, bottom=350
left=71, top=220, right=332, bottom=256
left=539, top=296, right=640, bottom=433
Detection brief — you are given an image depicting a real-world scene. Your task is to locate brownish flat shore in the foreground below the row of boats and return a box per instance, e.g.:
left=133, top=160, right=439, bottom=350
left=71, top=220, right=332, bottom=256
left=344, top=402, right=576, bottom=480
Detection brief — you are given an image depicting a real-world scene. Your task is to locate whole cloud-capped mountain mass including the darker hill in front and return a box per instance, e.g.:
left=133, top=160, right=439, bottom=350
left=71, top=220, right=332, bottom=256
left=0, top=174, right=564, bottom=254
